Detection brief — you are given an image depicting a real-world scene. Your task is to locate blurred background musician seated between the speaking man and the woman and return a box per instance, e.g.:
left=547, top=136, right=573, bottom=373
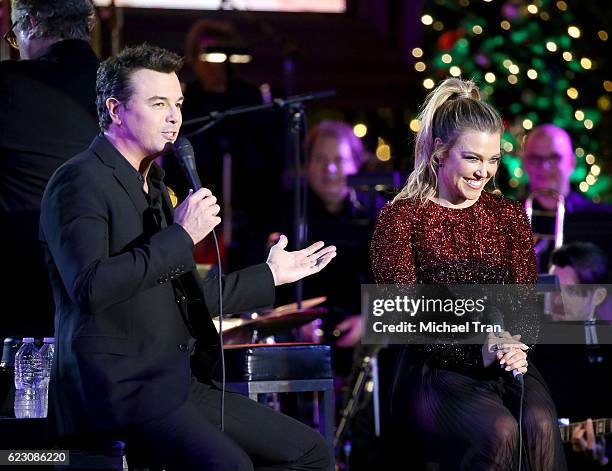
left=305, top=121, right=372, bottom=350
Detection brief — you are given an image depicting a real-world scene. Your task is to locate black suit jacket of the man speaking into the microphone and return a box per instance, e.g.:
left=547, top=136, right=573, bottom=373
left=41, top=135, right=274, bottom=435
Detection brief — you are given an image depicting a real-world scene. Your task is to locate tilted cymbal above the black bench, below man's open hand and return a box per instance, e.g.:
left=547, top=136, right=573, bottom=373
left=223, top=308, right=327, bottom=344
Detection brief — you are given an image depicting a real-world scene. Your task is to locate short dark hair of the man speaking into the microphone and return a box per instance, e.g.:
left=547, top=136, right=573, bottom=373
left=96, top=44, right=183, bottom=131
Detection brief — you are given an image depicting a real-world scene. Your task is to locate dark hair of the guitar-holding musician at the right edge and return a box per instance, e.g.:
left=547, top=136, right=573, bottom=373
left=552, top=242, right=608, bottom=285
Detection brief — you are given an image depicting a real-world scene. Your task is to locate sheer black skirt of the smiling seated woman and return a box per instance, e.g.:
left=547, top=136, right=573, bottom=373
left=391, top=352, right=567, bottom=471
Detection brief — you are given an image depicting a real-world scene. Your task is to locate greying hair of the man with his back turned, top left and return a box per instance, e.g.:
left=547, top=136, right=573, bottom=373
left=11, top=0, right=95, bottom=41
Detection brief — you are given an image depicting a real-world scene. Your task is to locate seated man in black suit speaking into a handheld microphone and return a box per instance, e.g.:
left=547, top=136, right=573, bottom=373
left=41, top=45, right=335, bottom=471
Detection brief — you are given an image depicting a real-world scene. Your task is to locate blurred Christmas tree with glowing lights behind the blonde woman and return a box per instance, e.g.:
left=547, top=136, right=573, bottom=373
left=410, top=0, right=612, bottom=201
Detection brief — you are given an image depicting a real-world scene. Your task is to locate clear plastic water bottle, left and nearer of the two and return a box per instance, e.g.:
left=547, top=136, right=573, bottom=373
left=15, top=337, right=43, bottom=419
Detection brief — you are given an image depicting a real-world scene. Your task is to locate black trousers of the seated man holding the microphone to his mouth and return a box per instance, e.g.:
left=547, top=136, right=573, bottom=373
left=123, top=380, right=331, bottom=471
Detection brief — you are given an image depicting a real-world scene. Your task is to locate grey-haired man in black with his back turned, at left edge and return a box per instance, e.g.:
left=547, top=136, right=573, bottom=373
left=0, top=0, right=99, bottom=340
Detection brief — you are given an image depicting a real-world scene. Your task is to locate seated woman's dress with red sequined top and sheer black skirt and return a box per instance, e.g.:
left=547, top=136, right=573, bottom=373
left=371, top=193, right=565, bottom=471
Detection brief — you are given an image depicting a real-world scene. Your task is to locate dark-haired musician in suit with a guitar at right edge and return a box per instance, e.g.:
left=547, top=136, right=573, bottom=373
left=534, top=242, right=612, bottom=471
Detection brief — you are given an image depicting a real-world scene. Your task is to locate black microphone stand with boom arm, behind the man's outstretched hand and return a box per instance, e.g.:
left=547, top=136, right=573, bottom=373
left=183, top=90, right=336, bottom=309
